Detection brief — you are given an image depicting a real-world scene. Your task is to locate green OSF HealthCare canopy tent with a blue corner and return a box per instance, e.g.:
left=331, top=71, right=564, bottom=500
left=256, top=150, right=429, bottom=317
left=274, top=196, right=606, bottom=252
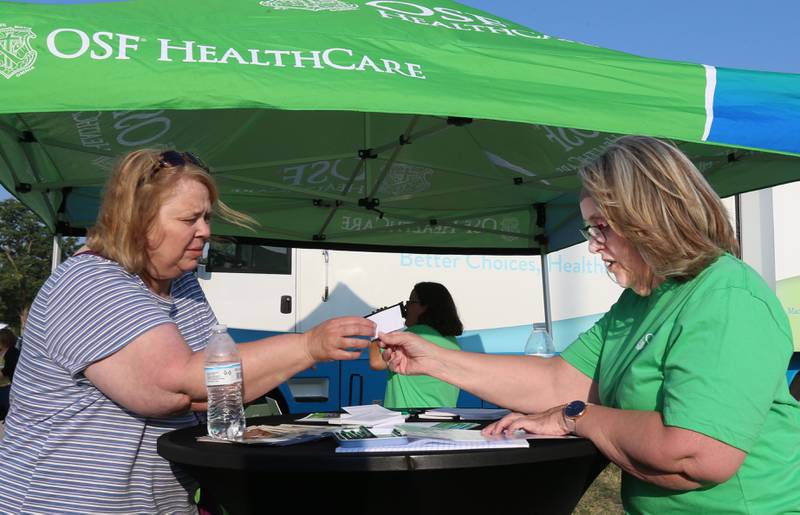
left=0, top=0, right=800, bottom=326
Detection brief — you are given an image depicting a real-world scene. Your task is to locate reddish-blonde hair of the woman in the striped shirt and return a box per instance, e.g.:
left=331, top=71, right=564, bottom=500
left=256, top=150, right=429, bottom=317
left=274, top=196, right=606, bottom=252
left=86, top=149, right=256, bottom=275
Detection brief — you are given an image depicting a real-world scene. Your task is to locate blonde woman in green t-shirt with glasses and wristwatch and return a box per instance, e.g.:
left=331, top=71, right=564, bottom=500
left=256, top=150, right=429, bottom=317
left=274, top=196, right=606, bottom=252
left=380, top=136, right=800, bottom=513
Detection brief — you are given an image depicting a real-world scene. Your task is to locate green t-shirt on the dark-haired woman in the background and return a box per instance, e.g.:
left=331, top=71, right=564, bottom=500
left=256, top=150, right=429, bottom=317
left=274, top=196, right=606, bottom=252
left=383, top=324, right=461, bottom=408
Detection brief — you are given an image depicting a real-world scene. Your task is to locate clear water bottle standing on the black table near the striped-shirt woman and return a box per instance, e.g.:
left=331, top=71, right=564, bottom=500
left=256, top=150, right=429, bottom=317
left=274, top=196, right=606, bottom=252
left=205, top=325, right=245, bottom=440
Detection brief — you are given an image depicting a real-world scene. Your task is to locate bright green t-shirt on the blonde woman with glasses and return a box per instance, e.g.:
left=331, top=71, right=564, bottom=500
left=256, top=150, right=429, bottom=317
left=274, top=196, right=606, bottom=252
left=561, top=254, right=800, bottom=514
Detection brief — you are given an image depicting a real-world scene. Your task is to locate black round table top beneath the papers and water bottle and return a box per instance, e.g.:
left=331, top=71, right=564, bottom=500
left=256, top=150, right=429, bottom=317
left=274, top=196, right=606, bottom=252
left=157, top=415, right=599, bottom=473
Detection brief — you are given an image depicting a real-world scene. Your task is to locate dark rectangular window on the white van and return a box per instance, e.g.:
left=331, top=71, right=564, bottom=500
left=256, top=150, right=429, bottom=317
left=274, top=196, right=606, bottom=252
left=206, top=241, right=292, bottom=275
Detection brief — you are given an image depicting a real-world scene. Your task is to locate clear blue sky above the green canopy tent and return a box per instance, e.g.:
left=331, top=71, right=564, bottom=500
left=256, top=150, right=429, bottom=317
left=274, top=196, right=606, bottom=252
left=0, top=0, right=800, bottom=200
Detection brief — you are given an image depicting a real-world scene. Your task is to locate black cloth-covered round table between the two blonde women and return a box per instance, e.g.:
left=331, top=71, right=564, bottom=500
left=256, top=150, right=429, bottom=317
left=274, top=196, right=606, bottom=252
left=158, top=416, right=606, bottom=515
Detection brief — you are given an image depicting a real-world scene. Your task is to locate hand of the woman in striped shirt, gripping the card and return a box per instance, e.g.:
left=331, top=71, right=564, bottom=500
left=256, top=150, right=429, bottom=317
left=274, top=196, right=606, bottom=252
left=303, top=317, right=375, bottom=362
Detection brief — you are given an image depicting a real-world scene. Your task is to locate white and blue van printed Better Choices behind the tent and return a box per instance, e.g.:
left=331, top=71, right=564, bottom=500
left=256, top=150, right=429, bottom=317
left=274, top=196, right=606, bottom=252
left=198, top=242, right=621, bottom=413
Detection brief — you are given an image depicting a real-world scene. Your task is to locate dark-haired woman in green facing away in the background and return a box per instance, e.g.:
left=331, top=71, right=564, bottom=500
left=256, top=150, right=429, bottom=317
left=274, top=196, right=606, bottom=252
left=369, top=282, right=464, bottom=408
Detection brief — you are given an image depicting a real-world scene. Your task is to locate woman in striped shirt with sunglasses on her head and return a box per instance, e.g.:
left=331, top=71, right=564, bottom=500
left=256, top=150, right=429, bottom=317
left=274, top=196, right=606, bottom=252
left=0, top=150, right=375, bottom=513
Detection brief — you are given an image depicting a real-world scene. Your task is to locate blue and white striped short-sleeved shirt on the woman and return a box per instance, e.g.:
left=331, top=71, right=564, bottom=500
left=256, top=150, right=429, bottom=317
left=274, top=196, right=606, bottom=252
left=0, top=254, right=216, bottom=513
